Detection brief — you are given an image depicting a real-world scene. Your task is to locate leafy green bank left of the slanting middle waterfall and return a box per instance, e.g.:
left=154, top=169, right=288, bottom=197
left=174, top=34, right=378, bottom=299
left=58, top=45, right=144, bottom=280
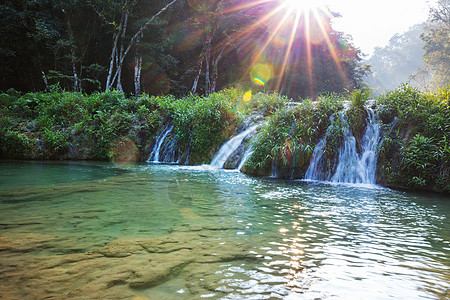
left=0, top=89, right=287, bottom=164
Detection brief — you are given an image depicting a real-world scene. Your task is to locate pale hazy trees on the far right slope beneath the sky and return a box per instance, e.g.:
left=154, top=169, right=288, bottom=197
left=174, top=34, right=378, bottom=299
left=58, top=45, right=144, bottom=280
left=364, top=0, right=450, bottom=94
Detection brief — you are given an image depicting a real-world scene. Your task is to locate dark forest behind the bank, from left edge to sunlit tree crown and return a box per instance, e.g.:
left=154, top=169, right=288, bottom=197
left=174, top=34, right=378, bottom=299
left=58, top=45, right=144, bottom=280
left=0, top=0, right=367, bottom=99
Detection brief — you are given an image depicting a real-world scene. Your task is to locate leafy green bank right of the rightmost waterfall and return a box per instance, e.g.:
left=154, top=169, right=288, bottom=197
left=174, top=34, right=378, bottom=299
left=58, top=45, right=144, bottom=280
left=377, top=85, right=450, bottom=193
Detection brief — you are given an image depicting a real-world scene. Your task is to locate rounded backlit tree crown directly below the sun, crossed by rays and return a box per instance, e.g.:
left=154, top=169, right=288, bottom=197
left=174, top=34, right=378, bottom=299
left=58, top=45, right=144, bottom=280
left=260, top=9, right=367, bottom=99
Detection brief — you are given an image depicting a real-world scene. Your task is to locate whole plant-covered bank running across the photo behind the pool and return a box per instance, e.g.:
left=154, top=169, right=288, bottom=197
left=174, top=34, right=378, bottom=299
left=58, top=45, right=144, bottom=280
left=0, top=86, right=450, bottom=193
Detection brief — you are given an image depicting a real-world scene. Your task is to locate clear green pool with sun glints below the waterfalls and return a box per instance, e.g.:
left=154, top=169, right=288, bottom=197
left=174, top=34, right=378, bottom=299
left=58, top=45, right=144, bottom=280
left=0, top=162, right=450, bottom=299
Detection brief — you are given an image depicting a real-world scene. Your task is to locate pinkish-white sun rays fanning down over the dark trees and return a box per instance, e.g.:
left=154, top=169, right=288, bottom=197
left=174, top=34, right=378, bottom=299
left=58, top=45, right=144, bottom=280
left=219, top=0, right=352, bottom=95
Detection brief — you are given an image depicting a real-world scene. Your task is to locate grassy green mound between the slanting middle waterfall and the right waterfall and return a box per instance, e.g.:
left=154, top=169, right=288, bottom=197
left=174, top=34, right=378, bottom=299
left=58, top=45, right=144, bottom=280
left=245, top=95, right=343, bottom=178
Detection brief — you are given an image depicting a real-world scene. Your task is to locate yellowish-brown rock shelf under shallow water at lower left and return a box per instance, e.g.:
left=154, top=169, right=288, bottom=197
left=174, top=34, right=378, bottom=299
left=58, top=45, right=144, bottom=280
left=0, top=224, right=266, bottom=299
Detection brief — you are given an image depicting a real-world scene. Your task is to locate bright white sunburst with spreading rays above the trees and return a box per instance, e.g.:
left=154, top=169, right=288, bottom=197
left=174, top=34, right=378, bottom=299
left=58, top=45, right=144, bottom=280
left=201, top=0, right=346, bottom=95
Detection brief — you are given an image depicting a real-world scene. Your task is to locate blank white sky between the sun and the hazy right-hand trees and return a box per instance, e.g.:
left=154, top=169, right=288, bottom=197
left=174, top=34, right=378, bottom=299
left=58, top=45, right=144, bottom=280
left=326, top=0, right=436, bottom=55
